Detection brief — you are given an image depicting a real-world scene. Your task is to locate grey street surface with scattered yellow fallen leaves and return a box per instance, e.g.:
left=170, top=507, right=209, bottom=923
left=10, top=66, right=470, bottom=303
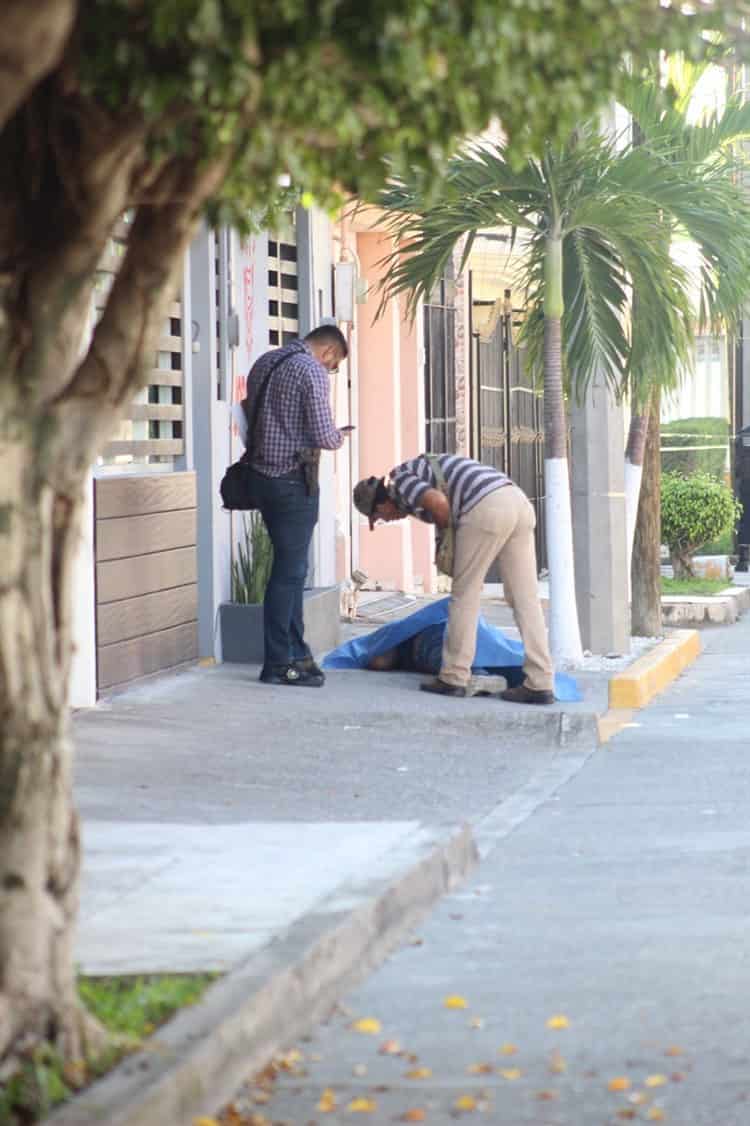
left=226, top=618, right=750, bottom=1126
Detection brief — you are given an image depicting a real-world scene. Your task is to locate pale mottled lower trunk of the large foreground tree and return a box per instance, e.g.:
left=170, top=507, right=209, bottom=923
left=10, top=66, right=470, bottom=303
left=0, top=423, right=106, bottom=1061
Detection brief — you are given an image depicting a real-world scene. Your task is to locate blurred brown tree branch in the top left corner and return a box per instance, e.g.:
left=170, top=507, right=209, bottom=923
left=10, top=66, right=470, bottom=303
left=0, top=0, right=77, bottom=129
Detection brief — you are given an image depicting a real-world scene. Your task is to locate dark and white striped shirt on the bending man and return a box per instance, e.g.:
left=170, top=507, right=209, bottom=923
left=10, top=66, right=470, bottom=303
left=389, top=454, right=512, bottom=524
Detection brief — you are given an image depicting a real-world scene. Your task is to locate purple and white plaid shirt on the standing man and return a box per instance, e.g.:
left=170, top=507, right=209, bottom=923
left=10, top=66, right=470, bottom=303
left=247, top=340, right=343, bottom=477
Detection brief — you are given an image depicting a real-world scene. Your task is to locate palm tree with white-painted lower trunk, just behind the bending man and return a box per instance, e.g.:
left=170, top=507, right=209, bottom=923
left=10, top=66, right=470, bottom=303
left=381, top=125, right=711, bottom=663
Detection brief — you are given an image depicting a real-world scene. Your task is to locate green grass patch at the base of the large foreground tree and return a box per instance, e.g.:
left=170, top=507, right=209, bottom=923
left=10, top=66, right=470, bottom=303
left=0, top=974, right=217, bottom=1126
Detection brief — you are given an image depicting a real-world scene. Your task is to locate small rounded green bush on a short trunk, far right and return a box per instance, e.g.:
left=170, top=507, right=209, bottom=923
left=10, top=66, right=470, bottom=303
left=661, top=473, right=742, bottom=579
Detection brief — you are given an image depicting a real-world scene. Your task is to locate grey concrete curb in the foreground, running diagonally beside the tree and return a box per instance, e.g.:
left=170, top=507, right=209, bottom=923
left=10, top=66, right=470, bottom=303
left=43, top=825, right=479, bottom=1126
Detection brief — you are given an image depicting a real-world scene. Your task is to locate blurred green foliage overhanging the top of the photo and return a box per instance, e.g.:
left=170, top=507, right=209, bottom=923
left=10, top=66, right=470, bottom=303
left=66, top=0, right=740, bottom=222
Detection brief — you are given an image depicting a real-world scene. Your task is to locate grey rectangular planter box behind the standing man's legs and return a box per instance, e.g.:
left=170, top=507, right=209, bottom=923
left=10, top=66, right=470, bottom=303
left=218, top=587, right=341, bottom=664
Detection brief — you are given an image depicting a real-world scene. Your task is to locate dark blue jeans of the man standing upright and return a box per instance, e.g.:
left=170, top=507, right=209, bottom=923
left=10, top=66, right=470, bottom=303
left=255, top=470, right=319, bottom=669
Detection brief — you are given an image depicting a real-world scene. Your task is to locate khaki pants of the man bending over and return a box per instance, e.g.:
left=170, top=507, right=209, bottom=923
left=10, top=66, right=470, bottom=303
left=440, top=485, right=554, bottom=691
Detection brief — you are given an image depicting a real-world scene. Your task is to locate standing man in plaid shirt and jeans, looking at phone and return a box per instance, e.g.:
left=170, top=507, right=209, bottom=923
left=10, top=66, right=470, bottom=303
left=245, top=324, right=351, bottom=688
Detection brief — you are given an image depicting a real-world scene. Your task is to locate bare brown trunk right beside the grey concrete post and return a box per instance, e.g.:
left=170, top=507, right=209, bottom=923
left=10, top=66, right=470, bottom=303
left=631, top=390, right=662, bottom=637
